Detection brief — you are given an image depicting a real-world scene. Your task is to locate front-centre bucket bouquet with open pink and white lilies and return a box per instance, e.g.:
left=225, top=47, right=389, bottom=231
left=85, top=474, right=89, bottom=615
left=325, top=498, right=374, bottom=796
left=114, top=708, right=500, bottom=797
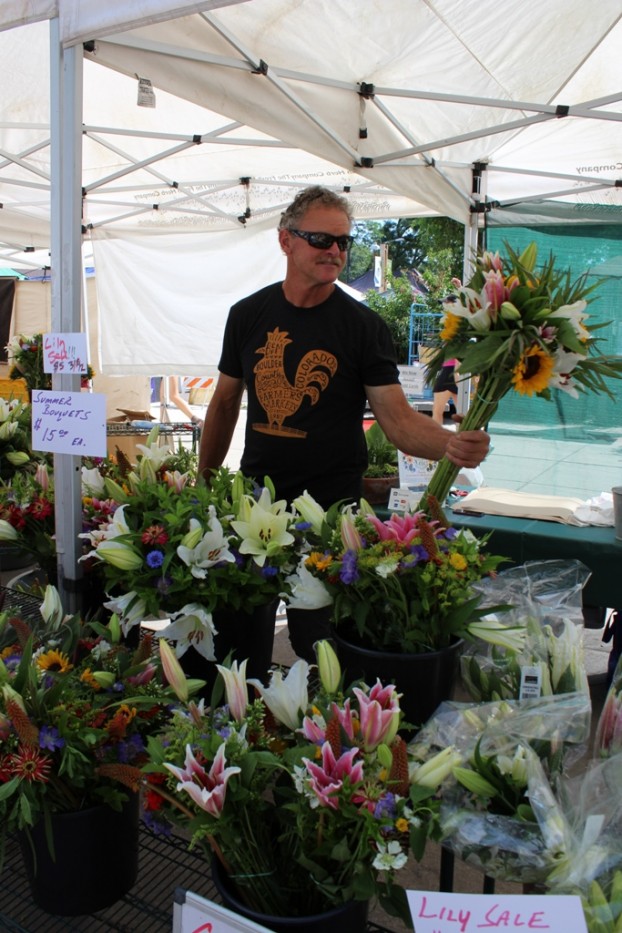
left=145, top=642, right=459, bottom=919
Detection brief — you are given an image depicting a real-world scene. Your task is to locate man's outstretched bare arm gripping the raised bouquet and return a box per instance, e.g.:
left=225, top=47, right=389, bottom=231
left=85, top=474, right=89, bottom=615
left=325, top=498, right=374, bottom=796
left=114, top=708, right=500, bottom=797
left=365, top=385, right=490, bottom=467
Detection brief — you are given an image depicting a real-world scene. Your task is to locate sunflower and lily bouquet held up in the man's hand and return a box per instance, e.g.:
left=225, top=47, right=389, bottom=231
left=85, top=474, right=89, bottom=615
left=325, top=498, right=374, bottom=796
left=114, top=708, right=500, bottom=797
left=426, top=243, right=622, bottom=503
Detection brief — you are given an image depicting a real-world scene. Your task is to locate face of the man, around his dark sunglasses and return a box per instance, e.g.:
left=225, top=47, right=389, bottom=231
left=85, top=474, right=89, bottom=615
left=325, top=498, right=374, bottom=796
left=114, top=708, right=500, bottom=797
left=279, top=205, right=350, bottom=286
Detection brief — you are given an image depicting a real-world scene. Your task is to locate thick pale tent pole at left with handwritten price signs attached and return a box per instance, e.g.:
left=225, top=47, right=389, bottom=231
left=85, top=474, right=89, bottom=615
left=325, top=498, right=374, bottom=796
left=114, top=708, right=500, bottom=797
left=50, top=19, right=82, bottom=612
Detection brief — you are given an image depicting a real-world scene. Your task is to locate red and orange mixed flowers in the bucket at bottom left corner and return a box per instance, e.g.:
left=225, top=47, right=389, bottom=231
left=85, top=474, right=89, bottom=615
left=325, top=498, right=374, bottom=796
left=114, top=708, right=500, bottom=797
left=0, top=586, right=180, bottom=864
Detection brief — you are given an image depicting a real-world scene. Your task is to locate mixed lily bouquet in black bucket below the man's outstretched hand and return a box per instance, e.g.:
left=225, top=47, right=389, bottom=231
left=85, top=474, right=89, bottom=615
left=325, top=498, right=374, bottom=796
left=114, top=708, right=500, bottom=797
left=287, top=495, right=523, bottom=653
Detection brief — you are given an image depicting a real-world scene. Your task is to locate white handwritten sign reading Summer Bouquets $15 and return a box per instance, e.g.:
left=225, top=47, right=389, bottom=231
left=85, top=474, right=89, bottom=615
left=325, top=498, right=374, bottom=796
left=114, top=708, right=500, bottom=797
left=32, top=389, right=106, bottom=457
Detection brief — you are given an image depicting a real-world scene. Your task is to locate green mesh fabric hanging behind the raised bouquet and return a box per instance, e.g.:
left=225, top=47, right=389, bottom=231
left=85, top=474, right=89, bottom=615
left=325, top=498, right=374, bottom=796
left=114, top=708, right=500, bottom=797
left=487, top=224, right=622, bottom=444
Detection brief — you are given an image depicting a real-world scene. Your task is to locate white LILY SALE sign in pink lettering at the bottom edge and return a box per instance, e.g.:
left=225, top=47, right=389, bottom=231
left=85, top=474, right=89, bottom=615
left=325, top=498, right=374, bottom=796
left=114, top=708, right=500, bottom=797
left=407, top=891, right=587, bottom=933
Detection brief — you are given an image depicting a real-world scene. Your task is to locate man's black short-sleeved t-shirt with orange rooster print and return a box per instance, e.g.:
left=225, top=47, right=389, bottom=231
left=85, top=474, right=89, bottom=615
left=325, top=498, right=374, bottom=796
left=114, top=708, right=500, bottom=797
left=218, top=283, right=399, bottom=508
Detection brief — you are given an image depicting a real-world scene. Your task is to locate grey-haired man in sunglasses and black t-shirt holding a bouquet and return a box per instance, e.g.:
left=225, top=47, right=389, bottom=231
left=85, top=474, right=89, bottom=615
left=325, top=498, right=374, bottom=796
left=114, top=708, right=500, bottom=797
left=199, top=186, right=490, bottom=661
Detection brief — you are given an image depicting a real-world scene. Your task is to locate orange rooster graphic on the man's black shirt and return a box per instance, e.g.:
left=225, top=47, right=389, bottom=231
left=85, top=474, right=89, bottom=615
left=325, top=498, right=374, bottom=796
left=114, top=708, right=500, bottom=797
left=253, top=327, right=337, bottom=437
